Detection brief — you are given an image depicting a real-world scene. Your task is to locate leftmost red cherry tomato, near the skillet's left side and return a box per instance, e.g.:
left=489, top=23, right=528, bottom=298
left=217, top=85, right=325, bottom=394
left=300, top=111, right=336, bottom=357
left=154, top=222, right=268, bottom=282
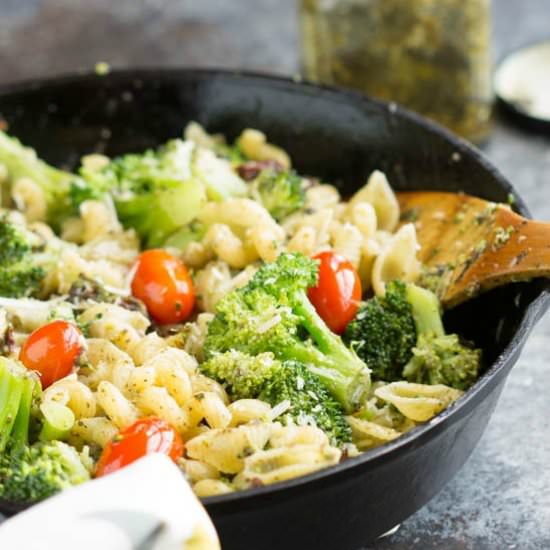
left=19, top=321, right=83, bottom=388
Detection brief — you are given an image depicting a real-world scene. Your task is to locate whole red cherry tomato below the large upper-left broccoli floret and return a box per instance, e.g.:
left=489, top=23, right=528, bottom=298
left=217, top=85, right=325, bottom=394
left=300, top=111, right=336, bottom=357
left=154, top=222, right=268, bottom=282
left=132, top=250, right=195, bottom=325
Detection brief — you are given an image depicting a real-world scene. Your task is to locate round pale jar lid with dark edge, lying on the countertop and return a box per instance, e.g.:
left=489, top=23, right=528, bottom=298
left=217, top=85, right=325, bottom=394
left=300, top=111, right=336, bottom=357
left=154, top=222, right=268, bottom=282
left=495, top=41, right=550, bottom=133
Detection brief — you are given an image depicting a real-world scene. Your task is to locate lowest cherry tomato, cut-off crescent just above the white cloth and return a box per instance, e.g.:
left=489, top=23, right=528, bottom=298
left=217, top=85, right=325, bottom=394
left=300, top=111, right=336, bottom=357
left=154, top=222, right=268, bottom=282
left=95, top=417, right=183, bottom=477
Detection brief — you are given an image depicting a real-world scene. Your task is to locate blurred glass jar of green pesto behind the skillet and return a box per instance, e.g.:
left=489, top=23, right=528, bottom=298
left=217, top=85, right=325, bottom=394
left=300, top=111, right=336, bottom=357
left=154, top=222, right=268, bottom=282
left=300, top=0, right=493, bottom=143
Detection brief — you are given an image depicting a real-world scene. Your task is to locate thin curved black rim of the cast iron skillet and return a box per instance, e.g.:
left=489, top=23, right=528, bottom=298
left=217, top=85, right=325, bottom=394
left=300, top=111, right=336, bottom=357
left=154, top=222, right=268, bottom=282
left=0, top=67, right=550, bottom=506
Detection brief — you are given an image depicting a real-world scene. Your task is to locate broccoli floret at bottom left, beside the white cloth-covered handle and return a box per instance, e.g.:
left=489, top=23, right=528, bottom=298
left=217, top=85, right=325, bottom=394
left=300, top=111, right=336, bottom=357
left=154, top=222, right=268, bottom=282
left=0, top=441, right=90, bottom=503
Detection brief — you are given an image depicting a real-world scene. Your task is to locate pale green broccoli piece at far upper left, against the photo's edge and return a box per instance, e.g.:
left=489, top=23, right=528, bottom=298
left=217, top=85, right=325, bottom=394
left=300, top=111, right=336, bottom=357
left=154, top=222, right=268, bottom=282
left=0, top=131, right=78, bottom=229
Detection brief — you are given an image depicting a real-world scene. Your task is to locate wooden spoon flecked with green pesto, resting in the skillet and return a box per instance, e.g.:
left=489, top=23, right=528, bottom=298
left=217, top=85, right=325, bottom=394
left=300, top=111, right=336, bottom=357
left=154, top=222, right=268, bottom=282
left=398, top=191, right=550, bottom=308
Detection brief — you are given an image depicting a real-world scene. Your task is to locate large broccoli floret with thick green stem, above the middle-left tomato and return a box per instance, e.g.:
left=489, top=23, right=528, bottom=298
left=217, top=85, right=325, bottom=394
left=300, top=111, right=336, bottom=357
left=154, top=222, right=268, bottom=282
left=77, top=139, right=206, bottom=247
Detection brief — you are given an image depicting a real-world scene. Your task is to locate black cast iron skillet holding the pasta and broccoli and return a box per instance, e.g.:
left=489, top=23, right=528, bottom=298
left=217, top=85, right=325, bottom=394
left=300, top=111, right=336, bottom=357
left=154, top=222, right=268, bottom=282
left=0, top=70, right=550, bottom=550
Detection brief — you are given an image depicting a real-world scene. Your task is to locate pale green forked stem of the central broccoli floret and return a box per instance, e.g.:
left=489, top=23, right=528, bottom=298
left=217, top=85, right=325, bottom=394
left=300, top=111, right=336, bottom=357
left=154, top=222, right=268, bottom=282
left=289, top=291, right=370, bottom=412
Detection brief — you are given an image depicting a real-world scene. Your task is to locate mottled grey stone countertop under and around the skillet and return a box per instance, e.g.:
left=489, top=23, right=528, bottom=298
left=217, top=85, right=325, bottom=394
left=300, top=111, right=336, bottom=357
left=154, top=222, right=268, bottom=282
left=0, top=0, right=550, bottom=550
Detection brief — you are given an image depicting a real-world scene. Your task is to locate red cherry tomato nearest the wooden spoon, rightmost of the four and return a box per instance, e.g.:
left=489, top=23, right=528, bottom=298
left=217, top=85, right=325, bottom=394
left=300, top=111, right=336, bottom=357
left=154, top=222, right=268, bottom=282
left=308, top=250, right=361, bottom=334
